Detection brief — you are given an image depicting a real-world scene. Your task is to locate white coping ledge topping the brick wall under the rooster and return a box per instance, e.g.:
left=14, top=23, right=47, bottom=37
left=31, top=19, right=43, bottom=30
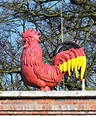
left=0, top=91, right=96, bottom=99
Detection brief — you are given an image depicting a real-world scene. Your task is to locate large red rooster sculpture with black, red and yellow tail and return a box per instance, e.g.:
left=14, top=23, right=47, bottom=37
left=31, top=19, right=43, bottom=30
left=21, top=29, right=86, bottom=91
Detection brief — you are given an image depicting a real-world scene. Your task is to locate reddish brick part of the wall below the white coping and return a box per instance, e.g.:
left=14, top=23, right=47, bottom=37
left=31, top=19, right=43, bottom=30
left=0, top=93, right=96, bottom=116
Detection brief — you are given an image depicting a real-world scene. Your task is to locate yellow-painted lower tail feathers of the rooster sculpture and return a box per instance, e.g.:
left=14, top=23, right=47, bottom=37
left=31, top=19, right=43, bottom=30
left=58, top=56, right=86, bottom=80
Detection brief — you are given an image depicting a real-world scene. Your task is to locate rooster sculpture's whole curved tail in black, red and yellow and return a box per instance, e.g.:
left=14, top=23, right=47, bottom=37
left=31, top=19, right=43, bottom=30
left=53, top=42, right=86, bottom=80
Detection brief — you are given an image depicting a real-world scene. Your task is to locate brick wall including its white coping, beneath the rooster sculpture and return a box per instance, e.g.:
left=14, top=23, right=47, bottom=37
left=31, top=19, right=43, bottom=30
left=0, top=91, right=96, bottom=116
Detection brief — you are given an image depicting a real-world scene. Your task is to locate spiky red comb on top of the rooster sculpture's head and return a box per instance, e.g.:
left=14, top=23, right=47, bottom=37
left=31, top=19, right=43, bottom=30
left=22, top=29, right=40, bottom=41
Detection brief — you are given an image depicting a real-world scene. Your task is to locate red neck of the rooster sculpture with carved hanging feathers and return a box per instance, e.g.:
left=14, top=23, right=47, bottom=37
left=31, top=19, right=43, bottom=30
left=22, top=41, right=42, bottom=66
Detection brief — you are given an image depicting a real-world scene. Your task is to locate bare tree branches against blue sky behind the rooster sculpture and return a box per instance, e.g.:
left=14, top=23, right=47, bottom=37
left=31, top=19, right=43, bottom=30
left=0, top=0, right=96, bottom=90
